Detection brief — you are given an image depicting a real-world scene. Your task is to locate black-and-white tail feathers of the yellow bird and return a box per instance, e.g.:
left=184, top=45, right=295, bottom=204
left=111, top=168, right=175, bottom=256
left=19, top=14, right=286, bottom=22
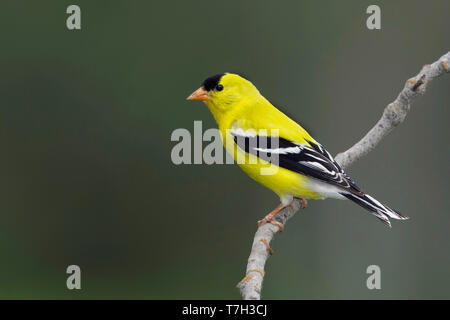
left=341, top=192, right=409, bottom=227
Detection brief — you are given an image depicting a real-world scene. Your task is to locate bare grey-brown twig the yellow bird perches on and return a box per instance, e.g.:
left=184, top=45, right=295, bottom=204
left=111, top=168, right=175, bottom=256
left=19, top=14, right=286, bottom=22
left=237, top=51, right=450, bottom=300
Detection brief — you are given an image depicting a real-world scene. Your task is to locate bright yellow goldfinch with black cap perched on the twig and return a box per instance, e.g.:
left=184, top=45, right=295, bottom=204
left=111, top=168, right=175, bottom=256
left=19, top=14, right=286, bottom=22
left=187, top=73, right=408, bottom=230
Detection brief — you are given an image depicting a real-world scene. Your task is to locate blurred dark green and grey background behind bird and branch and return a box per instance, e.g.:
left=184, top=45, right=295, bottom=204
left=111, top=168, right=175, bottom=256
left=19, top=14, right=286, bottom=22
left=0, top=0, right=450, bottom=299
